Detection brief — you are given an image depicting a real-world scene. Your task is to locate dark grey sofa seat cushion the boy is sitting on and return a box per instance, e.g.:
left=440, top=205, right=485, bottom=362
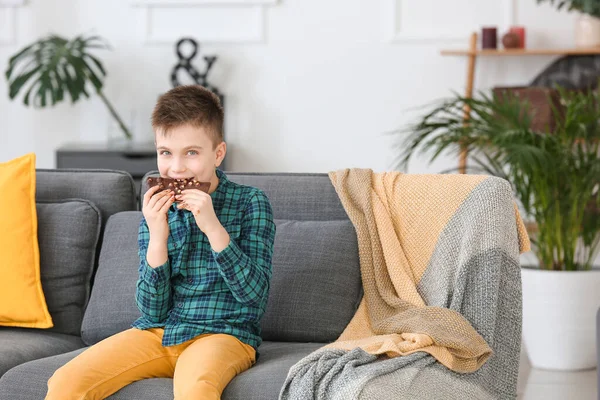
left=0, top=342, right=322, bottom=400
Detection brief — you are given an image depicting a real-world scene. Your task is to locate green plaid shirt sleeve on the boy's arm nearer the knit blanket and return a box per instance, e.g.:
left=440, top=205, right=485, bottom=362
left=213, top=190, right=275, bottom=306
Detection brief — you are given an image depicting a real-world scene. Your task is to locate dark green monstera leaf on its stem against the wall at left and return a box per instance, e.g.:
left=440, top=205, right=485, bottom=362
left=5, top=35, right=132, bottom=139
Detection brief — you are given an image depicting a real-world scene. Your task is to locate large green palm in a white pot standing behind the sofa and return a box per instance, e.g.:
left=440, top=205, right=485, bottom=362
left=397, top=90, right=600, bottom=370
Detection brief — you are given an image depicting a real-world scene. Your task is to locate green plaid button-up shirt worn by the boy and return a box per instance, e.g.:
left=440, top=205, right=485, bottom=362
left=132, top=170, right=275, bottom=349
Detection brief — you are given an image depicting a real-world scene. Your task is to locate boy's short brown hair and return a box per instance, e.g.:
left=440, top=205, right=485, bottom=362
left=152, top=85, right=224, bottom=148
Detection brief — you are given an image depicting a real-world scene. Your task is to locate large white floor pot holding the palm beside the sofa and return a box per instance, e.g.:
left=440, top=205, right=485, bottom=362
left=521, top=268, right=600, bottom=371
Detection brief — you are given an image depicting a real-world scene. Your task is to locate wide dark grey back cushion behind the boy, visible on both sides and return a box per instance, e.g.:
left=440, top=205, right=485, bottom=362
left=82, top=211, right=362, bottom=345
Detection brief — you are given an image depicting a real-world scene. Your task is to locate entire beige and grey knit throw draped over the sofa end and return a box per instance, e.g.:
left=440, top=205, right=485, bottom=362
left=279, top=170, right=529, bottom=400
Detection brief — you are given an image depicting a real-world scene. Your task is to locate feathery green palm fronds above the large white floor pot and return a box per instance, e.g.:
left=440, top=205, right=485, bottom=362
left=397, top=90, right=600, bottom=271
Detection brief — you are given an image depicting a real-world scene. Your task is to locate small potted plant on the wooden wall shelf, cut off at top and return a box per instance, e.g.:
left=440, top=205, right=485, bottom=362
left=536, top=0, right=600, bottom=47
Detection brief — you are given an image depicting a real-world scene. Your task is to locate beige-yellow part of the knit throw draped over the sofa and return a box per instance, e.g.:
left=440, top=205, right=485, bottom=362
left=326, top=169, right=529, bottom=373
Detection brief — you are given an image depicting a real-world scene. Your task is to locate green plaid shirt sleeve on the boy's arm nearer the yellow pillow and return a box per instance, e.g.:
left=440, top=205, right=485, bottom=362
left=135, top=217, right=172, bottom=322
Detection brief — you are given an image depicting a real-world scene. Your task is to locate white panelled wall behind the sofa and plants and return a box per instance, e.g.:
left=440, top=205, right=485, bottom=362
left=0, top=0, right=574, bottom=172
